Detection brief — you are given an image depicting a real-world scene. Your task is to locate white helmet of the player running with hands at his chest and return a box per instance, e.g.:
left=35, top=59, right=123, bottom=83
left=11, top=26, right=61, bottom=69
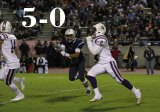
left=93, top=23, right=106, bottom=36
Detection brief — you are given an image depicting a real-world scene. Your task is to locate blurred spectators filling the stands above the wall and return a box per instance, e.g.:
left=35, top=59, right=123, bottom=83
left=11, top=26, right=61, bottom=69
left=0, top=0, right=160, bottom=42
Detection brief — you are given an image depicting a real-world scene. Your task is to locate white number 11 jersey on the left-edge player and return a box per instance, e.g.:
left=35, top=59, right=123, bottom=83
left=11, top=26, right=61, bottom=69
left=0, top=33, right=20, bottom=69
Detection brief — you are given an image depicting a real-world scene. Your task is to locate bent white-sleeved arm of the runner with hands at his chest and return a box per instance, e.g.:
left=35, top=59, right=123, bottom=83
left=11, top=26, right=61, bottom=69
left=86, top=36, right=104, bottom=55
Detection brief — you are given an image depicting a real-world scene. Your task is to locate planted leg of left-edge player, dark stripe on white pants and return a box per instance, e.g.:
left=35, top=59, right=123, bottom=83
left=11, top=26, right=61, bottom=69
left=5, top=69, right=24, bottom=101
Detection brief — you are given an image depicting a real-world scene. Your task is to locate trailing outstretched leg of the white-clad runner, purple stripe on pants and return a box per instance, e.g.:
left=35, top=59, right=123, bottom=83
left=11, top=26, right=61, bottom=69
left=105, top=61, right=141, bottom=104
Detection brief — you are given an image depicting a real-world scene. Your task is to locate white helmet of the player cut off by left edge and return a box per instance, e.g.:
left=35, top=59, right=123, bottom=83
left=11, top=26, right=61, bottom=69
left=0, top=21, right=12, bottom=33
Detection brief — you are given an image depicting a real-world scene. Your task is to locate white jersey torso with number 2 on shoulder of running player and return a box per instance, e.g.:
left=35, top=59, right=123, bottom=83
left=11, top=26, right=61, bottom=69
left=92, top=35, right=114, bottom=64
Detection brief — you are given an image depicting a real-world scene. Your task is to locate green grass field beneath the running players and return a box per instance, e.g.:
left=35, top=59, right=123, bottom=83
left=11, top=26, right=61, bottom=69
left=0, top=74, right=160, bottom=112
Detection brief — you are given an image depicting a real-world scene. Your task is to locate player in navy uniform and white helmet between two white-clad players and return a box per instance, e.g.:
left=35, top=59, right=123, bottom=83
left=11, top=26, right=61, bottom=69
left=61, top=29, right=91, bottom=94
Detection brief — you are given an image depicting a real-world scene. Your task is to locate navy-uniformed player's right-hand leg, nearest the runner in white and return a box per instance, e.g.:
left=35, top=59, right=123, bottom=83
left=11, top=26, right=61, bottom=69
left=78, top=58, right=91, bottom=94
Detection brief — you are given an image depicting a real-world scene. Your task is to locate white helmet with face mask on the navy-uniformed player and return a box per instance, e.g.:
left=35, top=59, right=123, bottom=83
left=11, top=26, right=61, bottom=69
left=65, top=29, right=75, bottom=42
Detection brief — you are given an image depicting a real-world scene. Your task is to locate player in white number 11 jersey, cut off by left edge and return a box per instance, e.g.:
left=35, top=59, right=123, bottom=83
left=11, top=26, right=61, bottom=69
left=0, top=21, right=24, bottom=101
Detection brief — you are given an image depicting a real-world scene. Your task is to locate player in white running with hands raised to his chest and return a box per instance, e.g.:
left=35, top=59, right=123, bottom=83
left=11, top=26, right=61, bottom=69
left=86, top=23, right=141, bottom=104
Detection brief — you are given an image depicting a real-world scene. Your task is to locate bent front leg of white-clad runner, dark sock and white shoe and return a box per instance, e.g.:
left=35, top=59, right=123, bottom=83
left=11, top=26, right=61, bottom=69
left=87, top=64, right=105, bottom=101
